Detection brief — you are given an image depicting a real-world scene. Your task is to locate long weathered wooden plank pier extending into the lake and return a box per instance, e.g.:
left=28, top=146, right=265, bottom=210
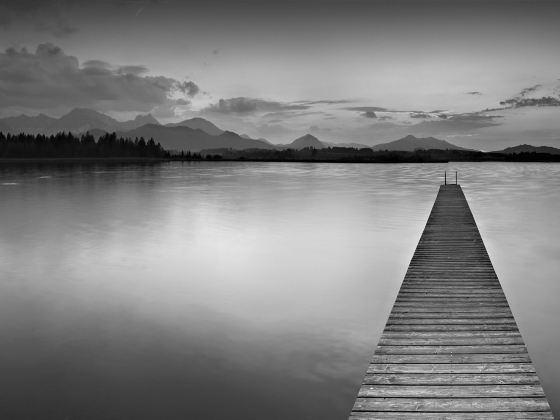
left=350, top=185, right=554, bottom=420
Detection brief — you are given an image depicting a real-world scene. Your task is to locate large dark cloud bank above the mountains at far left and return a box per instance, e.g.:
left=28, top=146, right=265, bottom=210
left=0, top=43, right=198, bottom=112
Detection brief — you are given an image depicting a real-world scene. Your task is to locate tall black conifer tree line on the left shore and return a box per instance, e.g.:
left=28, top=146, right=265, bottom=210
left=0, top=132, right=169, bottom=158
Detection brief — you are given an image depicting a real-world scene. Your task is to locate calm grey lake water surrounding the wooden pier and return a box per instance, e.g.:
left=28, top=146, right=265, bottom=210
left=0, top=162, right=560, bottom=420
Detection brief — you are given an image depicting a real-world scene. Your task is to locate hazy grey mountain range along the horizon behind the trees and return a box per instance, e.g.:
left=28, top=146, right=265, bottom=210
left=6, top=108, right=544, bottom=154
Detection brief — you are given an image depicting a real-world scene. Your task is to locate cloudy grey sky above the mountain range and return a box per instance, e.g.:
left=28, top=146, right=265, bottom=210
left=0, top=0, right=560, bottom=150
